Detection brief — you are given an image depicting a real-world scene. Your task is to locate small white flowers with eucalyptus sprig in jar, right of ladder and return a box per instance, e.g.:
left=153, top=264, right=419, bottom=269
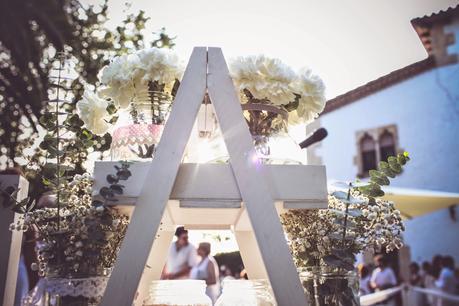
left=281, top=152, right=409, bottom=306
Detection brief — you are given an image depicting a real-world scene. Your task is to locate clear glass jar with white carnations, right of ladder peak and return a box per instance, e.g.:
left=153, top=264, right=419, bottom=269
left=230, top=56, right=325, bottom=164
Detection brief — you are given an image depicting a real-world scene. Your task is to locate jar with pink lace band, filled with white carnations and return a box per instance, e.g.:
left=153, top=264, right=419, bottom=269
left=79, top=48, right=183, bottom=160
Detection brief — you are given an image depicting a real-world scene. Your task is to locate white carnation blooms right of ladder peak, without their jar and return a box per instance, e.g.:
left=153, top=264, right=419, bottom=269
left=230, top=55, right=326, bottom=133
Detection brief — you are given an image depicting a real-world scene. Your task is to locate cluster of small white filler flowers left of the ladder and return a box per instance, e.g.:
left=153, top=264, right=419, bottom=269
left=18, top=173, right=129, bottom=278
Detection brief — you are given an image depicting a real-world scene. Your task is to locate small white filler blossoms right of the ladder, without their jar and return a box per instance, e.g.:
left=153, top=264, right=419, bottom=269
left=282, top=192, right=404, bottom=270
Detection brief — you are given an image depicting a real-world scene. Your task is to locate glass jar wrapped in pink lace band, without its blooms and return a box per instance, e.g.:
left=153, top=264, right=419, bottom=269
left=110, top=91, right=172, bottom=160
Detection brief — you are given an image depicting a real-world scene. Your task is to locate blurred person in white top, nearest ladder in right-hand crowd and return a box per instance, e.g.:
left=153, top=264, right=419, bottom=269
left=370, top=255, right=397, bottom=306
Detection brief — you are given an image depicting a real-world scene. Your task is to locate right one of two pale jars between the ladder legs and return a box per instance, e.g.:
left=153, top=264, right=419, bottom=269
left=215, top=280, right=277, bottom=306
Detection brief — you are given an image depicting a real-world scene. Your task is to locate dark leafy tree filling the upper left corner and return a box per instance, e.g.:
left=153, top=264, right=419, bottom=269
left=0, top=0, right=174, bottom=166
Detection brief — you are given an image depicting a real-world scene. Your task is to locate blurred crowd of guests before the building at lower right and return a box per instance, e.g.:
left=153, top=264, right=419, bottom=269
left=359, top=255, right=459, bottom=306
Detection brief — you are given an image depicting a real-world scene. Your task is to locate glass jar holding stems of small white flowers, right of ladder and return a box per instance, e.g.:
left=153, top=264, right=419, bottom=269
left=298, top=267, right=360, bottom=306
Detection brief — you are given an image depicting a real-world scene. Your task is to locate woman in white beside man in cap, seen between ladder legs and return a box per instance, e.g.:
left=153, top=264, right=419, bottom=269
left=190, top=242, right=220, bottom=303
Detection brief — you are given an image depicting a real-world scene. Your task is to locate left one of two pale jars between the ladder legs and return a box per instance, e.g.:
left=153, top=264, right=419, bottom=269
left=145, top=280, right=212, bottom=306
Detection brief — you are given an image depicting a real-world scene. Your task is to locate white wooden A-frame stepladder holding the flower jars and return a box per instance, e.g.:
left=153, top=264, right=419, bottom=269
left=99, top=47, right=326, bottom=306
